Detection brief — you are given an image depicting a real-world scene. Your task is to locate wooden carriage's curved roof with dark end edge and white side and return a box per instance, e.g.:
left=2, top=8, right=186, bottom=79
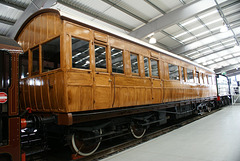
left=15, top=9, right=214, bottom=73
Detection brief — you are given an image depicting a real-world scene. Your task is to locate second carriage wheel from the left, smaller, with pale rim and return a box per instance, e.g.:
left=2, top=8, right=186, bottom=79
left=130, top=121, right=146, bottom=139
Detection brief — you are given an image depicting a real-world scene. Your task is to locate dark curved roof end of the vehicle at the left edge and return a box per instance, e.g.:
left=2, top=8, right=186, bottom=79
left=0, top=36, right=23, bottom=54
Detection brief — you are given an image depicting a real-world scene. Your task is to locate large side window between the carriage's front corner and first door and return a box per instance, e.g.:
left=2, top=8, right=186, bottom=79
left=72, top=37, right=90, bottom=69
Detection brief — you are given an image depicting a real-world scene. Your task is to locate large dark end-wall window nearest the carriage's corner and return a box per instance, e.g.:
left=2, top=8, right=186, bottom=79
left=42, top=37, right=60, bottom=72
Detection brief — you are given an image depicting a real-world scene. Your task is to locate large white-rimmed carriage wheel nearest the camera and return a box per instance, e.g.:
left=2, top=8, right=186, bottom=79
left=71, top=129, right=102, bottom=156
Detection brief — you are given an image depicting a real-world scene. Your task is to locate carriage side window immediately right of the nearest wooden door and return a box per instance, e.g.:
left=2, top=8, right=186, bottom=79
left=111, top=48, right=124, bottom=73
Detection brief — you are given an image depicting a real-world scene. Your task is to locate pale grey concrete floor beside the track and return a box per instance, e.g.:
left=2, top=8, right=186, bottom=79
left=102, top=104, right=240, bottom=161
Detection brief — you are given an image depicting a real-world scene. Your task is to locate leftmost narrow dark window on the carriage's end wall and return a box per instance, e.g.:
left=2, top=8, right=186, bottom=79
left=19, top=51, right=28, bottom=78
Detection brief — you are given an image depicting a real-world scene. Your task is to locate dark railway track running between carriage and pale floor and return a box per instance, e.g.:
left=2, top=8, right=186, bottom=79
left=72, top=108, right=222, bottom=161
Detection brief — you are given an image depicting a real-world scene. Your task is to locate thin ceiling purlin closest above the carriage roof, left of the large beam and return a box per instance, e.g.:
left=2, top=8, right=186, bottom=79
left=58, top=0, right=132, bottom=32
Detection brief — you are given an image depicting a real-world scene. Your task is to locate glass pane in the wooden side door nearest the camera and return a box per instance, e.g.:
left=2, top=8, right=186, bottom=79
left=95, top=45, right=107, bottom=69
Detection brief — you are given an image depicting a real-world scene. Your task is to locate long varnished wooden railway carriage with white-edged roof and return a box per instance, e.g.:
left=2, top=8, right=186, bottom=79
left=15, top=9, right=216, bottom=155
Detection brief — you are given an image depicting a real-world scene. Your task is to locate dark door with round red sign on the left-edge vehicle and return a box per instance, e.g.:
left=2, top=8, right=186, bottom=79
left=0, top=51, right=11, bottom=146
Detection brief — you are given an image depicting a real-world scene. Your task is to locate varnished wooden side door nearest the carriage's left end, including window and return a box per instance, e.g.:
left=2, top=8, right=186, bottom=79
left=93, top=33, right=112, bottom=109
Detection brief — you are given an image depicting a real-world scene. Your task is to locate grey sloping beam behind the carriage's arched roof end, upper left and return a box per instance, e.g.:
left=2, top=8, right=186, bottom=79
left=7, top=0, right=57, bottom=38
